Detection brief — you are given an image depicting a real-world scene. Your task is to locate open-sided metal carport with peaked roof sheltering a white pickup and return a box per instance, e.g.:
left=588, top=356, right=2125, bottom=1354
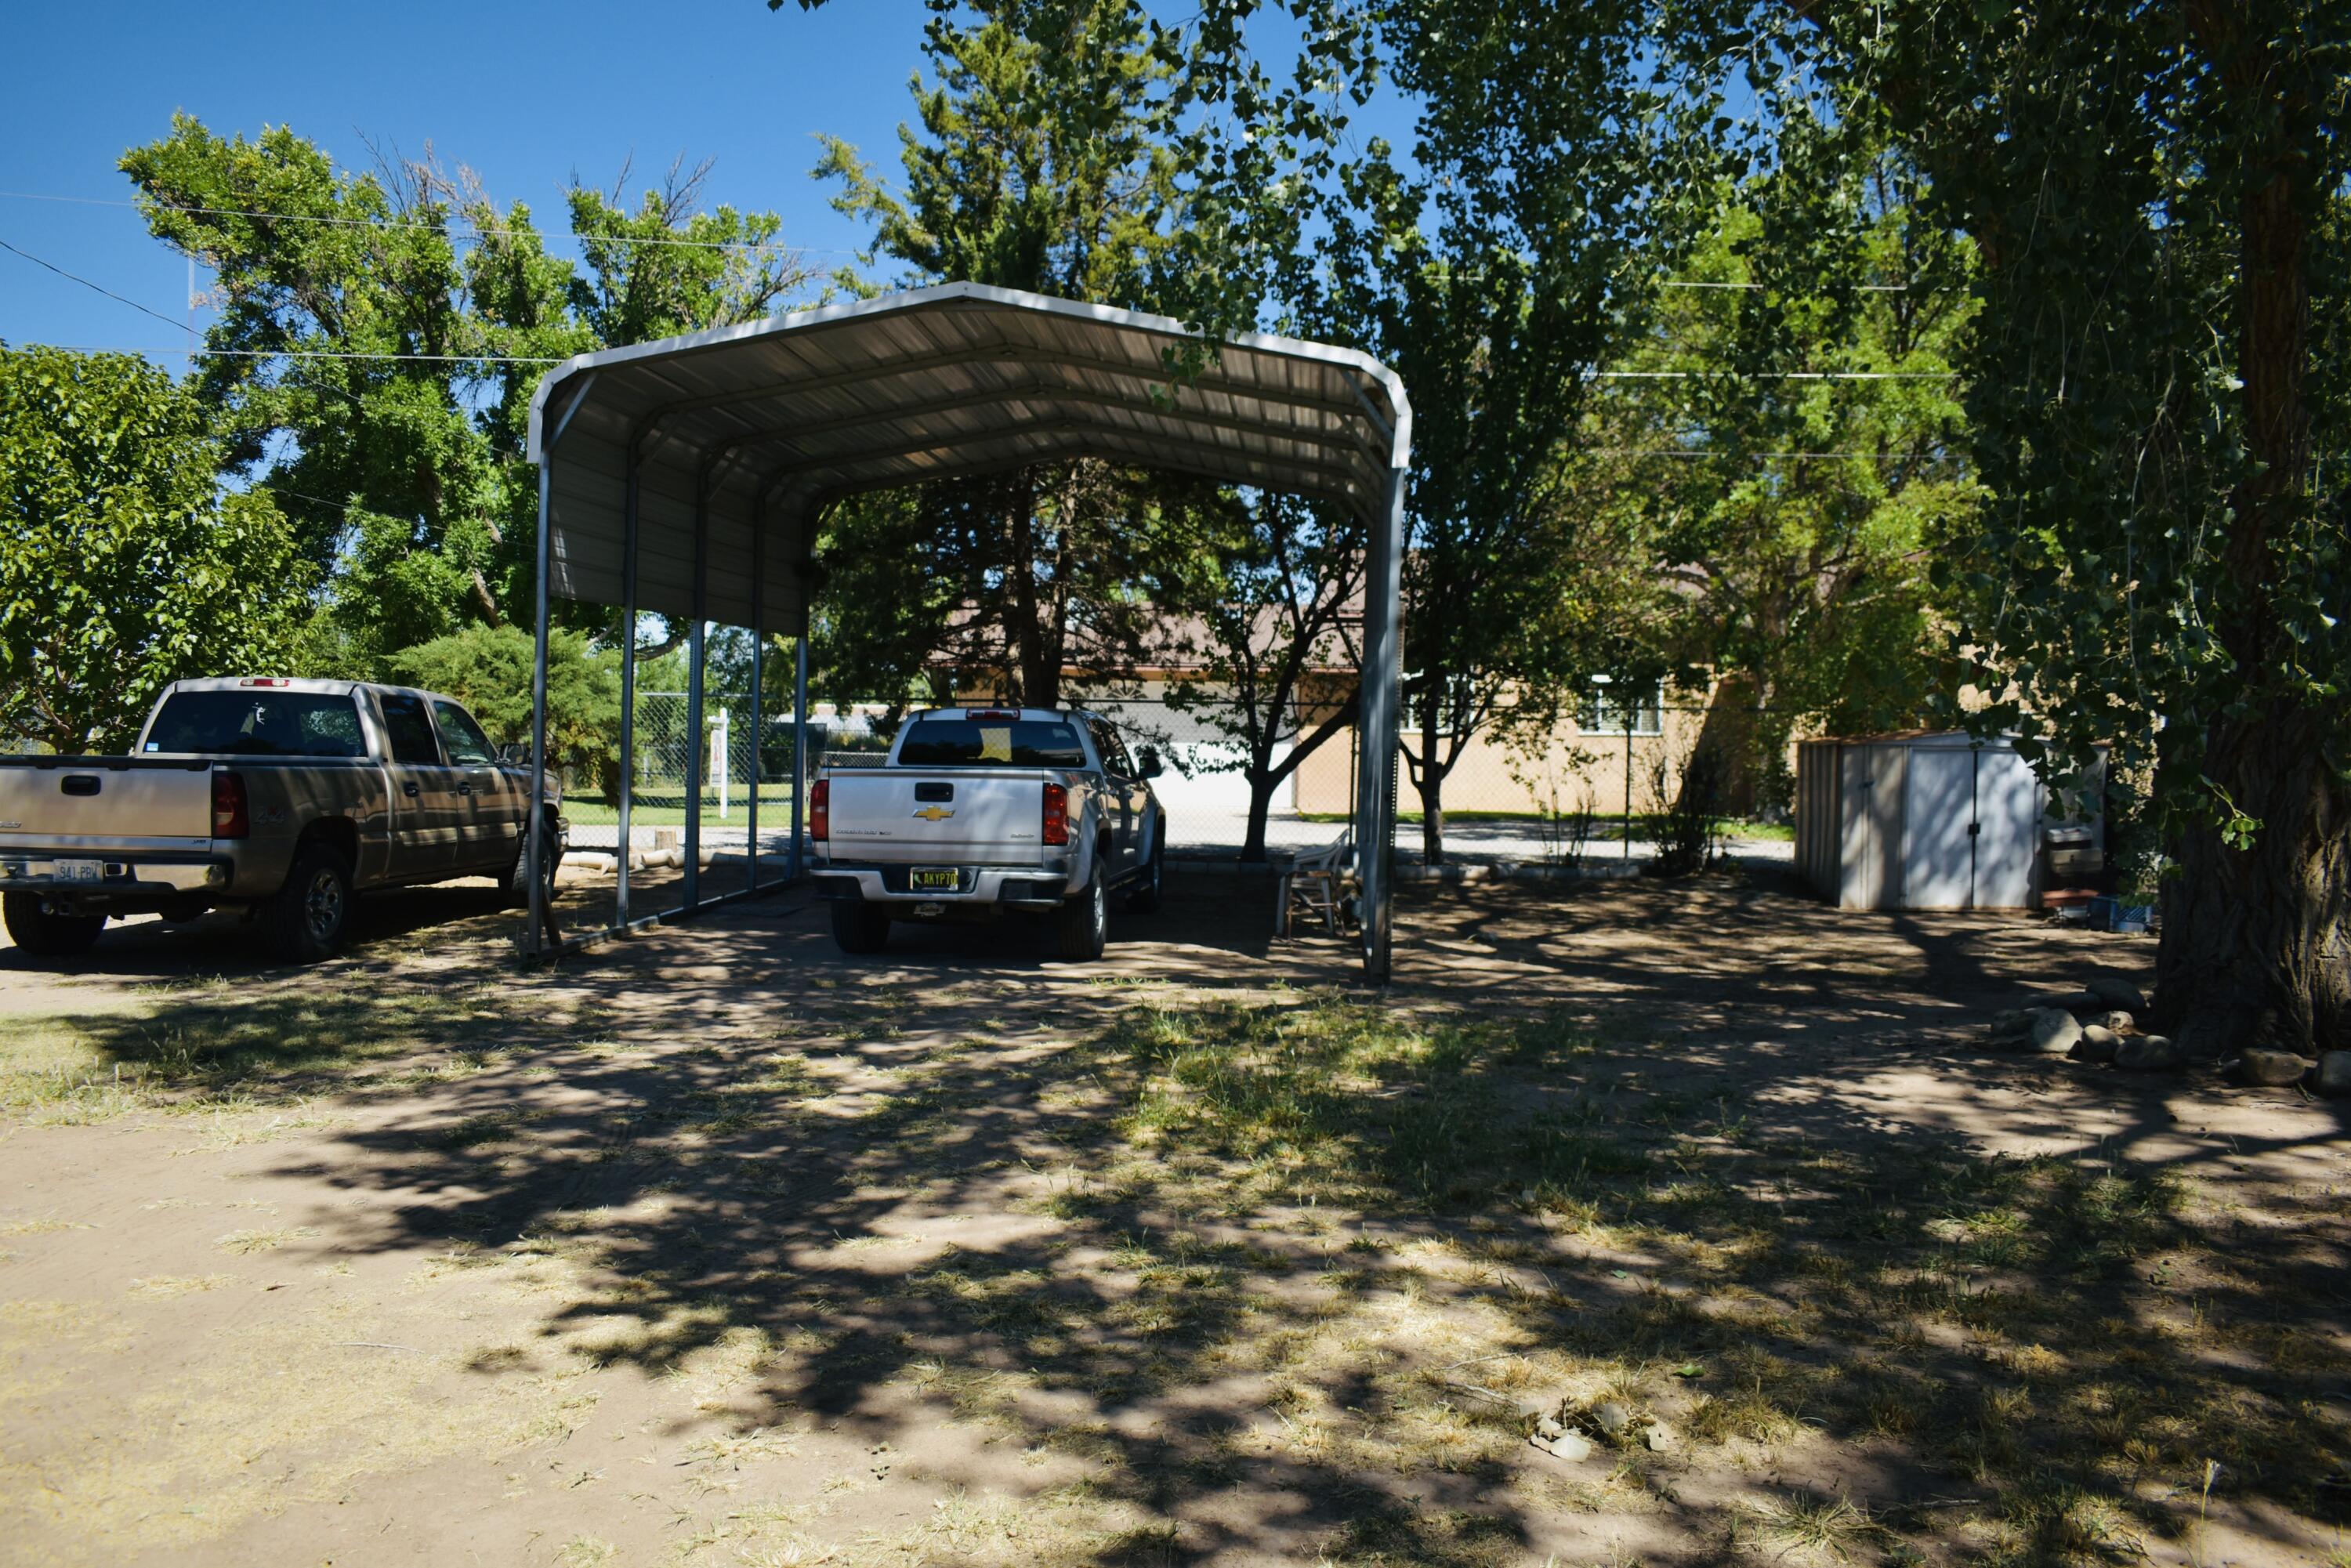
left=524, top=282, right=1413, bottom=980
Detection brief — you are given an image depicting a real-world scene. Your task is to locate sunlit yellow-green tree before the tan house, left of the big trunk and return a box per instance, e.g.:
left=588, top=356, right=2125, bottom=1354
left=1599, top=138, right=1982, bottom=811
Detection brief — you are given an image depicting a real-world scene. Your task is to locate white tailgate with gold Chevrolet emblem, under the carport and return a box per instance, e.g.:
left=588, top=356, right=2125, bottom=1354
left=825, top=769, right=1051, bottom=865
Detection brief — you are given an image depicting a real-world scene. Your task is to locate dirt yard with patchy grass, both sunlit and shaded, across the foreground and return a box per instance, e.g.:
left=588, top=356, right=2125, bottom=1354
left=0, top=872, right=2351, bottom=1568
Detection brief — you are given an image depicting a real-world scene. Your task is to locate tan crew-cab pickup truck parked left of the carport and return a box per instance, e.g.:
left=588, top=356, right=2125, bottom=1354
left=0, top=677, right=564, bottom=964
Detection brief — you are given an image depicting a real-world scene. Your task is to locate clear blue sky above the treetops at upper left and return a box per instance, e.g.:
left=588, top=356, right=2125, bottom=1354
left=0, top=0, right=964, bottom=371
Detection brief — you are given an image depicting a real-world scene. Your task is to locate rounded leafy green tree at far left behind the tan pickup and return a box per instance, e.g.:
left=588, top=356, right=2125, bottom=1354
left=0, top=346, right=313, bottom=752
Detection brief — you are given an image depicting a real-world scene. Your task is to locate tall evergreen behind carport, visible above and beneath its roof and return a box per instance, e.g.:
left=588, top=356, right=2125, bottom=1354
left=816, top=0, right=1230, bottom=705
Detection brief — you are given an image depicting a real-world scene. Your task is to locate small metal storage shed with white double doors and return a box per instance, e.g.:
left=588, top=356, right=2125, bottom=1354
left=1796, top=731, right=2099, bottom=910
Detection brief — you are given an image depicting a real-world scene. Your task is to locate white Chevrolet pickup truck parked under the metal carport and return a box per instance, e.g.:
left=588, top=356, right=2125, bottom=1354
left=809, top=708, right=1168, bottom=959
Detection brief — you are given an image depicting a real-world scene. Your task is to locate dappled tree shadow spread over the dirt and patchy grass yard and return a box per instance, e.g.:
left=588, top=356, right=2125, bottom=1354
left=9, top=882, right=2351, bottom=1566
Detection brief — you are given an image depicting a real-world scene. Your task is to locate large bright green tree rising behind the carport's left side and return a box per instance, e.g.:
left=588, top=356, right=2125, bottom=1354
left=122, top=115, right=806, bottom=672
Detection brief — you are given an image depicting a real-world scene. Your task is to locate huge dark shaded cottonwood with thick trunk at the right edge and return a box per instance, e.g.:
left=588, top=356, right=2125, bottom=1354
left=1806, top=0, right=2351, bottom=1056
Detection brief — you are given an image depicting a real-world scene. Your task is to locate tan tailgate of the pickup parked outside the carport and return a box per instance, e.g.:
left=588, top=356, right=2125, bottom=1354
left=0, top=757, right=212, bottom=849
